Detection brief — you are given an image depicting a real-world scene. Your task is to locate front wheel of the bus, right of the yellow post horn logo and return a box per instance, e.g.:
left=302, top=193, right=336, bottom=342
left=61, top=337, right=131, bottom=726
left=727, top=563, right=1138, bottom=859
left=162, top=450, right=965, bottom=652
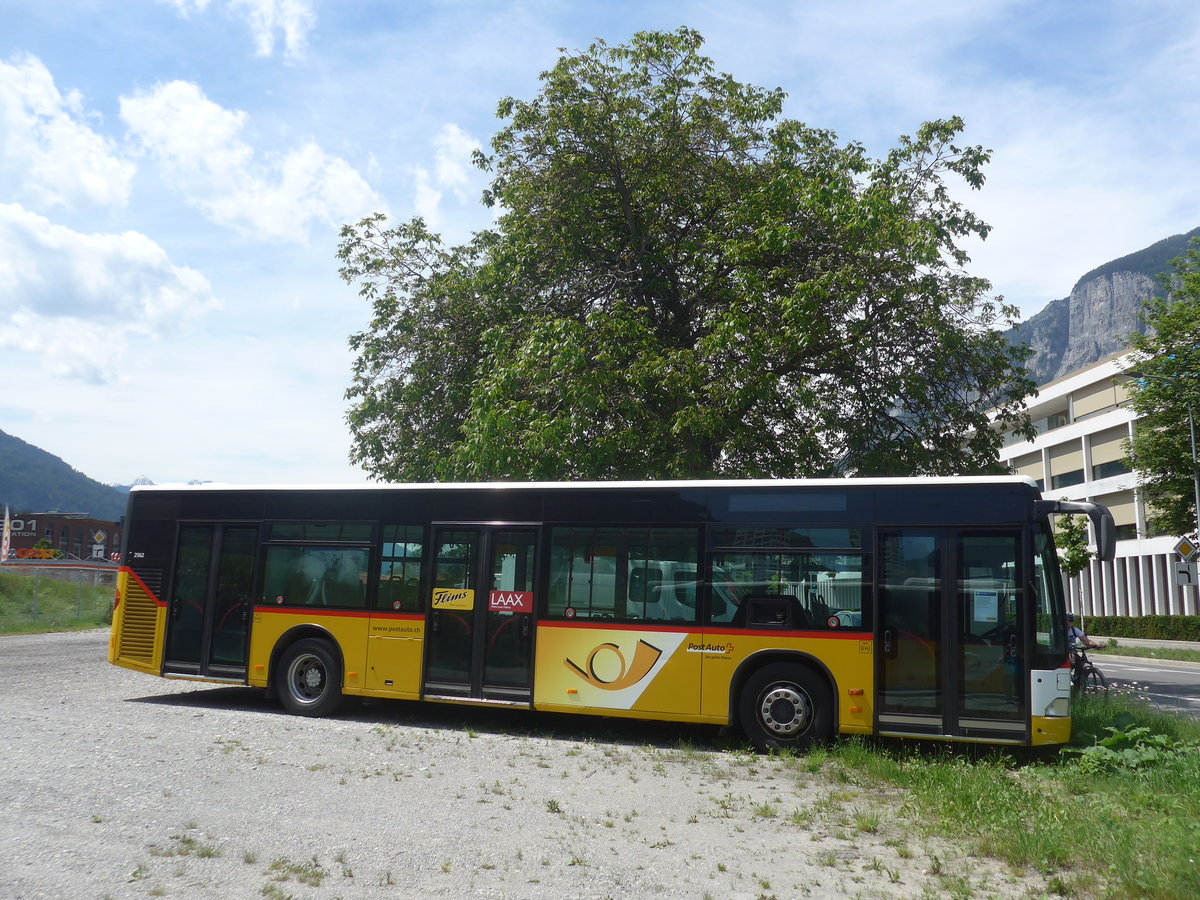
left=739, top=662, right=833, bottom=752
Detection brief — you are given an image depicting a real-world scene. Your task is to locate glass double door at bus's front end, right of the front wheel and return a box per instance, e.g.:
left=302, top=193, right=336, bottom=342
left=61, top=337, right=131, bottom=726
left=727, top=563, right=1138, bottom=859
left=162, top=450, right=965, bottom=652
left=876, top=528, right=1028, bottom=743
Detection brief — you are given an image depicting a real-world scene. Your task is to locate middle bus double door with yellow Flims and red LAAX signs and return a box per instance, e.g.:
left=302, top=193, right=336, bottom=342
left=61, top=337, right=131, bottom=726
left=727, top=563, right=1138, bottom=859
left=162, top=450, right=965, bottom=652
left=424, top=526, right=538, bottom=703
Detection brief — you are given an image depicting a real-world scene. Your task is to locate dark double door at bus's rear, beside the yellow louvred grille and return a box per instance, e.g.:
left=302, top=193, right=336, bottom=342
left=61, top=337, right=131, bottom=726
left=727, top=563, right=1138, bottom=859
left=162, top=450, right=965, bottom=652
left=163, top=523, right=258, bottom=682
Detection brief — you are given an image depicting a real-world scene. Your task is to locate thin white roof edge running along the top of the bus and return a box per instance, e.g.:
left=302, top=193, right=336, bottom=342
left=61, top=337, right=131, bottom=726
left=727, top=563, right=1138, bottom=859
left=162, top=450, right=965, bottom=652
left=130, top=475, right=1037, bottom=493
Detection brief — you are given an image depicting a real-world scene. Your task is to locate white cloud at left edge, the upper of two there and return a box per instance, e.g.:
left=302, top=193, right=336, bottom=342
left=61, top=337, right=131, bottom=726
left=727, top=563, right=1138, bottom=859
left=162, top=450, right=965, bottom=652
left=0, top=55, right=136, bottom=206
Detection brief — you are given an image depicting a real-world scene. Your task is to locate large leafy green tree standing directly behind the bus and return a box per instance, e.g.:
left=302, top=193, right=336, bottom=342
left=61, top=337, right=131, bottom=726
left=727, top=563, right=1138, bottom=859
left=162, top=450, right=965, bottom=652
left=338, top=29, right=1033, bottom=481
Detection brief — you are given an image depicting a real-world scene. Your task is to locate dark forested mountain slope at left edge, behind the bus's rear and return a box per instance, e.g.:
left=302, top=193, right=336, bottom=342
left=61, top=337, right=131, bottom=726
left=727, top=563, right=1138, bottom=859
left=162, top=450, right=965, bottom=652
left=0, top=431, right=128, bottom=522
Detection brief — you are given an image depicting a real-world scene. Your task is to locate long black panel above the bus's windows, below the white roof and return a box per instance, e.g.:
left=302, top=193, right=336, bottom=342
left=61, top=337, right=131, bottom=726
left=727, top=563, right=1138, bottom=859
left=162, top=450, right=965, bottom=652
left=130, top=479, right=1039, bottom=526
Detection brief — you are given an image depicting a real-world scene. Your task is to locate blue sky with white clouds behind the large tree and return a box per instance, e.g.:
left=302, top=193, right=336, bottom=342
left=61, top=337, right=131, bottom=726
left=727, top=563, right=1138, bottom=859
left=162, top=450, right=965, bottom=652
left=0, top=0, right=1200, bottom=484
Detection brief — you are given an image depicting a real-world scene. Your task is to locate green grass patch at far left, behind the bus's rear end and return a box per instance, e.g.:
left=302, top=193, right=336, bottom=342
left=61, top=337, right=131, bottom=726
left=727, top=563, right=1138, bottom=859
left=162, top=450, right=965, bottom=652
left=0, top=571, right=114, bottom=635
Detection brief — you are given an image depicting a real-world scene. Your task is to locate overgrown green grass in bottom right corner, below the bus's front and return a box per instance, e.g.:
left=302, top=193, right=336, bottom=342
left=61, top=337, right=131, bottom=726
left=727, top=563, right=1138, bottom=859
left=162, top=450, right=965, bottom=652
left=824, top=696, right=1200, bottom=900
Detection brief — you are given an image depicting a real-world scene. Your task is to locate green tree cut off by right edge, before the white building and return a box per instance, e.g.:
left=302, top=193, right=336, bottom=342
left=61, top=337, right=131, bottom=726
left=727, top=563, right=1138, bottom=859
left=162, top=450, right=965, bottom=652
left=1128, top=239, right=1200, bottom=534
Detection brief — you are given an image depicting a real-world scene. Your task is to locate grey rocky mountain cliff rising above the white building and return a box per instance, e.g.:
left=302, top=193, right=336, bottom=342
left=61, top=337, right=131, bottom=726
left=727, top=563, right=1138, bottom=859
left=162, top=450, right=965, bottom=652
left=1008, top=228, right=1200, bottom=384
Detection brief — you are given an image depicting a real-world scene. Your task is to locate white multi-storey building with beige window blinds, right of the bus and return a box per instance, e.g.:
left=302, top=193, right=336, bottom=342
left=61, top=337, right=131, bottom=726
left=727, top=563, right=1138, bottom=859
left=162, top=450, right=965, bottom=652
left=1000, top=353, right=1200, bottom=616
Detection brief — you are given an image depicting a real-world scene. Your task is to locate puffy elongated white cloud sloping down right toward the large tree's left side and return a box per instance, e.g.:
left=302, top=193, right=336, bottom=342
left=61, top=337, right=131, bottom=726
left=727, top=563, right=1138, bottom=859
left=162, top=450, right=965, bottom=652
left=121, top=82, right=383, bottom=242
